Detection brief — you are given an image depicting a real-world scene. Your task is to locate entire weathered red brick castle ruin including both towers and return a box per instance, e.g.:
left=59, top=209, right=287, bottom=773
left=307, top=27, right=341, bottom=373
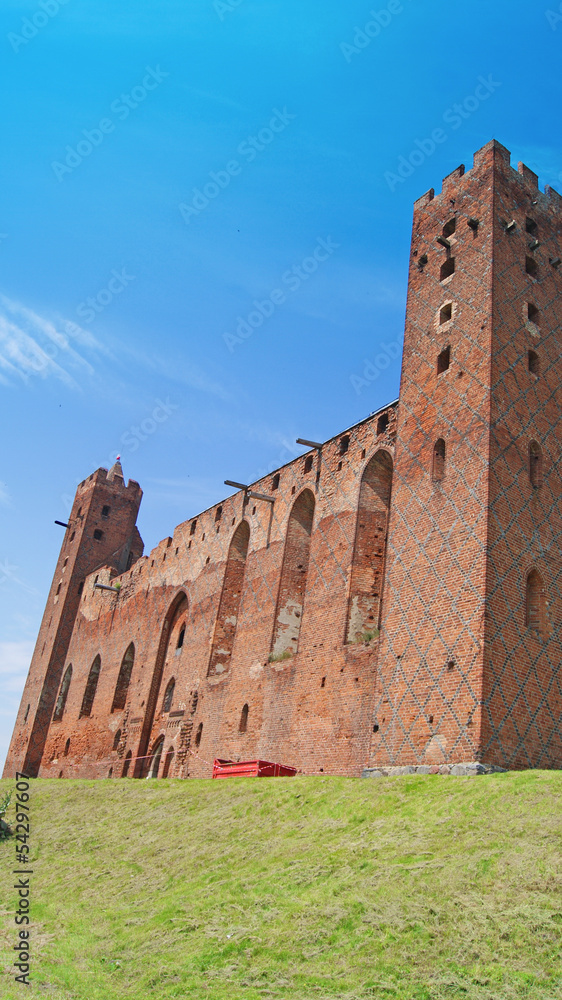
left=5, top=141, right=562, bottom=777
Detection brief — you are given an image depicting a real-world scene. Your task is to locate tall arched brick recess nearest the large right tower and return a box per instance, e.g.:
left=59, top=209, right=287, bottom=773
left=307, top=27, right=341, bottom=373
left=346, top=451, right=393, bottom=642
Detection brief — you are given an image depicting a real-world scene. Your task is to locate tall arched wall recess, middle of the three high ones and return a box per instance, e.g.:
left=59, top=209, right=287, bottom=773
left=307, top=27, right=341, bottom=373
left=270, top=490, right=315, bottom=661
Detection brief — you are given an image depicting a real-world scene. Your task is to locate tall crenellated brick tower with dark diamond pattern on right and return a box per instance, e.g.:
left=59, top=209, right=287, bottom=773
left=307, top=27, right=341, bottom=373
left=369, top=141, right=562, bottom=767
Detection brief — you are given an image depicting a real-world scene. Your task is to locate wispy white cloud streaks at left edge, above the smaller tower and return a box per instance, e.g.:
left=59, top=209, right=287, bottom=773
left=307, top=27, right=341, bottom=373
left=0, top=294, right=106, bottom=389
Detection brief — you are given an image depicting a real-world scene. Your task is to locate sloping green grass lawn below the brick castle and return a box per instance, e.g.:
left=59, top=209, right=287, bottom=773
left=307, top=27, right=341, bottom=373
left=0, top=771, right=562, bottom=1000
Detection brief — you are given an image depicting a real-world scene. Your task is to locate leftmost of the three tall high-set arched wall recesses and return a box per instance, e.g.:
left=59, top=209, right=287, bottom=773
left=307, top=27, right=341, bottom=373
left=208, top=521, right=250, bottom=677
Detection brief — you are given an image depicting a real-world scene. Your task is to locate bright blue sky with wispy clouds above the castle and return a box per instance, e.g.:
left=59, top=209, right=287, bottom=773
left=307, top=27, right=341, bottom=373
left=0, top=0, right=562, bottom=760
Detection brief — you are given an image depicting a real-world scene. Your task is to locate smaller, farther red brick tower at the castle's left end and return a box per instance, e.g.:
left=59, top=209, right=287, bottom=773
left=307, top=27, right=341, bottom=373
left=4, top=461, right=143, bottom=777
